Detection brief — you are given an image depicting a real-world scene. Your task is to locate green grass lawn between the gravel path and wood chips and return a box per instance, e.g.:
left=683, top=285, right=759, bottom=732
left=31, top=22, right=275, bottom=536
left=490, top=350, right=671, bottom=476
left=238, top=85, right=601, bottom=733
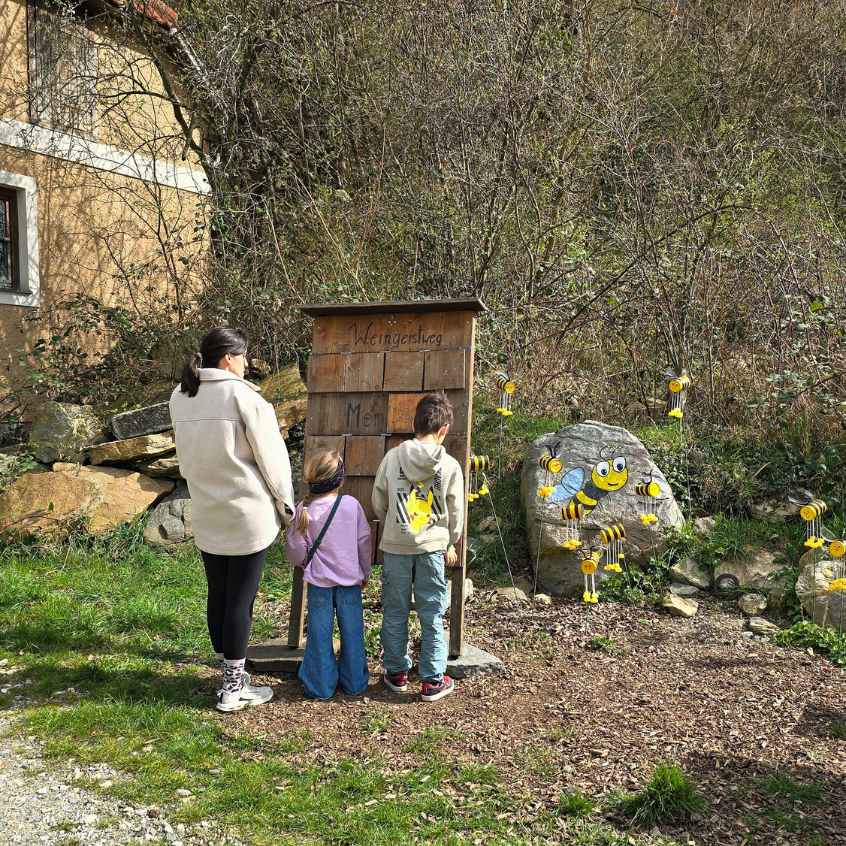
left=0, top=526, right=688, bottom=846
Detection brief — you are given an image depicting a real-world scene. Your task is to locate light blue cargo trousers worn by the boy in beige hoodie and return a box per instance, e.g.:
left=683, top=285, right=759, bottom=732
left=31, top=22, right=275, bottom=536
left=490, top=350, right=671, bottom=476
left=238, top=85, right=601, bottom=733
left=382, top=552, right=448, bottom=681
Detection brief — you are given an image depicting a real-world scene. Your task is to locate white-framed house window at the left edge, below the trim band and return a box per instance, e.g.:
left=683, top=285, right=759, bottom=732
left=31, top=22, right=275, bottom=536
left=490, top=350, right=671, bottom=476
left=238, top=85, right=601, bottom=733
left=0, top=170, right=40, bottom=307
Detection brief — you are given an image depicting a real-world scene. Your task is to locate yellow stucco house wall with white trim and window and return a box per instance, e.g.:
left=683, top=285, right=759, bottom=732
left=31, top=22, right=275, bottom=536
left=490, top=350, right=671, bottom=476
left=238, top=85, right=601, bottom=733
left=0, top=0, right=208, bottom=404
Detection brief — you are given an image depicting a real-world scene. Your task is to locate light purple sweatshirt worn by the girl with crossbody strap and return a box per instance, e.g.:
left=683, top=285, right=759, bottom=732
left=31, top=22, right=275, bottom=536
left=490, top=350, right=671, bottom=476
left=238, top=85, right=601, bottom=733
left=285, top=494, right=371, bottom=587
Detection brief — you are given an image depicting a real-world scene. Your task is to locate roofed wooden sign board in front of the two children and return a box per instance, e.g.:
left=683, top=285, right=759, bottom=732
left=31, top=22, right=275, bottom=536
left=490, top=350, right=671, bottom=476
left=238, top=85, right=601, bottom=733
left=288, top=299, right=485, bottom=657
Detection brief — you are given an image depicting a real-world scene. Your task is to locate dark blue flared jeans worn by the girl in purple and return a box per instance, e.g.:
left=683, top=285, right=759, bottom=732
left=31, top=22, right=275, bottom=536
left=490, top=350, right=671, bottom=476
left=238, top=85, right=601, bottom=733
left=299, top=584, right=369, bottom=699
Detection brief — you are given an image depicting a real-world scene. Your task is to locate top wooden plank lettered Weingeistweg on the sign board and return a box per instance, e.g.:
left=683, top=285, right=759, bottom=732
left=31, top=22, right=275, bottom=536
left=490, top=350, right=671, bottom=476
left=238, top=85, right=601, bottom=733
left=312, top=311, right=474, bottom=353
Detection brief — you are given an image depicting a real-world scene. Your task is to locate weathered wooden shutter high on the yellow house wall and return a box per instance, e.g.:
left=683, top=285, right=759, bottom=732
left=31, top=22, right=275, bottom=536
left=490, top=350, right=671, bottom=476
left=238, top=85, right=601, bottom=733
left=27, top=0, right=98, bottom=137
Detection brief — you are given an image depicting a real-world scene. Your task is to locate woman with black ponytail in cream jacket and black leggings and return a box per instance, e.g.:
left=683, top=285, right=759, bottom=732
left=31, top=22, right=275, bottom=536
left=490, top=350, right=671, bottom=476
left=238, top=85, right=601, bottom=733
left=170, top=328, right=294, bottom=711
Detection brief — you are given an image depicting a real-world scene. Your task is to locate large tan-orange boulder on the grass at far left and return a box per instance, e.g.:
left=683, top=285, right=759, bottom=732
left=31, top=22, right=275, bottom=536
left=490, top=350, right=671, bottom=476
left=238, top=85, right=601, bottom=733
left=0, top=463, right=173, bottom=536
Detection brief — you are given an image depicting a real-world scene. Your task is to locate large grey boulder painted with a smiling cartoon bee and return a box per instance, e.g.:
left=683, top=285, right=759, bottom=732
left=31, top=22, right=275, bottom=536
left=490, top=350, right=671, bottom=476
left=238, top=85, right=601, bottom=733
left=521, top=420, right=684, bottom=596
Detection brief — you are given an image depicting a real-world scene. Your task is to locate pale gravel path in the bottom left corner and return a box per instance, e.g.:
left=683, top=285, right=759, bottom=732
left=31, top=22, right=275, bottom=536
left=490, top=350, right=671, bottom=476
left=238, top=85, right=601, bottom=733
left=0, top=716, right=232, bottom=846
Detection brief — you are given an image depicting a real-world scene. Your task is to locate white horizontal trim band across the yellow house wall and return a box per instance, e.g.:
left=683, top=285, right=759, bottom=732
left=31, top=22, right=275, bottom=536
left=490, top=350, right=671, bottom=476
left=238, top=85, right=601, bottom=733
left=0, top=117, right=209, bottom=194
